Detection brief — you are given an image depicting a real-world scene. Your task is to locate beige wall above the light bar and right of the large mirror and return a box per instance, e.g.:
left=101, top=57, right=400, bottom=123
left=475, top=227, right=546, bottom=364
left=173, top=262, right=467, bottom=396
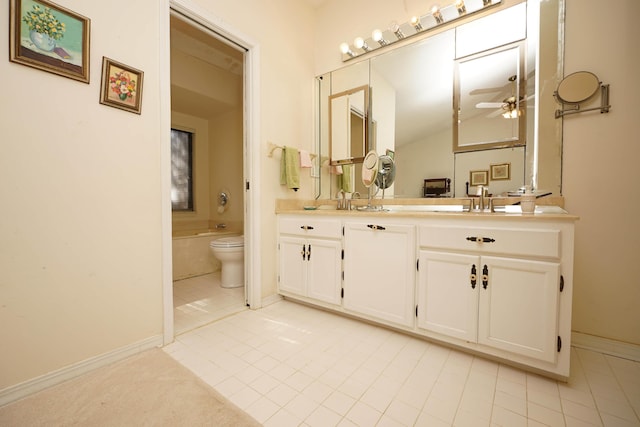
left=316, top=0, right=640, bottom=345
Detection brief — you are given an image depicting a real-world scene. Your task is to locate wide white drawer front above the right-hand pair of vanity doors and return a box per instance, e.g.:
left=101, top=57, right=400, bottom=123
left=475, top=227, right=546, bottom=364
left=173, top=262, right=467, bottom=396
left=419, top=225, right=560, bottom=258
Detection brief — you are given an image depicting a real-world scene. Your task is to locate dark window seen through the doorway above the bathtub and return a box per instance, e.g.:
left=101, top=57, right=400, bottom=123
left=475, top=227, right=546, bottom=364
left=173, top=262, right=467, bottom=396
left=171, top=129, right=193, bottom=212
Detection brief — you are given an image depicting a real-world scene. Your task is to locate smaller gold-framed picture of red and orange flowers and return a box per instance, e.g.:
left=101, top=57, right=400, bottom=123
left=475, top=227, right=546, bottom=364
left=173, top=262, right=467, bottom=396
left=100, top=57, right=144, bottom=114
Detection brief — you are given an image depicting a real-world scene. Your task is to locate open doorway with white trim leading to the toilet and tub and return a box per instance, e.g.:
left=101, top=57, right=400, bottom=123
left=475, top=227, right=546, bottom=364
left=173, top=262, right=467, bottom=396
left=161, top=0, right=261, bottom=343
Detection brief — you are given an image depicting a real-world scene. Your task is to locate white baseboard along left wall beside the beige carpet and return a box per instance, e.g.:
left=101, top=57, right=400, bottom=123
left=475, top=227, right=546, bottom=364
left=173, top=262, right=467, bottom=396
left=0, top=335, right=162, bottom=407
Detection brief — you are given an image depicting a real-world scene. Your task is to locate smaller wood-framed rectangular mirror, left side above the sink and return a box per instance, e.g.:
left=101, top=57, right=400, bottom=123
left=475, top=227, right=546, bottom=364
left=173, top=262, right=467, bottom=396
left=329, top=86, right=369, bottom=165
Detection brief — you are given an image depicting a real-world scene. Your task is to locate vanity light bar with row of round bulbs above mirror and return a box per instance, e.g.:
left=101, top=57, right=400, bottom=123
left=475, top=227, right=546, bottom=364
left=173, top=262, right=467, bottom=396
left=340, top=0, right=504, bottom=61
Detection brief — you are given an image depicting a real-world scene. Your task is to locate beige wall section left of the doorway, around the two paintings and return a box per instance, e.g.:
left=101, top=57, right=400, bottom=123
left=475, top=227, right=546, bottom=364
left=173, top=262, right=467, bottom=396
left=0, top=0, right=162, bottom=390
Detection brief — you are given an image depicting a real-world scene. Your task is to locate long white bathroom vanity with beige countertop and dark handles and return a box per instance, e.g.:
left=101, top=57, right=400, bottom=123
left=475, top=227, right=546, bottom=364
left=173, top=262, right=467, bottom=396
left=278, top=206, right=577, bottom=380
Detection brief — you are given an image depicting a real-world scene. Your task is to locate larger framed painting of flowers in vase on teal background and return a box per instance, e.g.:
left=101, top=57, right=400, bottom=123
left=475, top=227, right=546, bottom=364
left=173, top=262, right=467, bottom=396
left=9, top=0, right=91, bottom=83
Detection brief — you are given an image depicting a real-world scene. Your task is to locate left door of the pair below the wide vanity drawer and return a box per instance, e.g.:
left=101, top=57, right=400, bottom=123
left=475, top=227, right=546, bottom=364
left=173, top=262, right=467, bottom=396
left=418, top=251, right=481, bottom=342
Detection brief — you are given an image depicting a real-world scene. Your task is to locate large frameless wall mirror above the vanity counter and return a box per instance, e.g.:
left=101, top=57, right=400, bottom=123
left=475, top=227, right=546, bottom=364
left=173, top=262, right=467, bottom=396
left=318, top=0, right=564, bottom=198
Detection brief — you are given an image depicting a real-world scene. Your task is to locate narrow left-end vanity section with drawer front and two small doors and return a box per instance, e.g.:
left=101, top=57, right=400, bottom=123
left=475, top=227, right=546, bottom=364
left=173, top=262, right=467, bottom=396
left=278, top=215, right=342, bottom=305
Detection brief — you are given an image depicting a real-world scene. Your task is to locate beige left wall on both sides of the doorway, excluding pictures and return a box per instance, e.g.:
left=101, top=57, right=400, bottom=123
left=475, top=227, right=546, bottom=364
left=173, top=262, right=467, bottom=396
left=0, top=0, right=314, bottom=393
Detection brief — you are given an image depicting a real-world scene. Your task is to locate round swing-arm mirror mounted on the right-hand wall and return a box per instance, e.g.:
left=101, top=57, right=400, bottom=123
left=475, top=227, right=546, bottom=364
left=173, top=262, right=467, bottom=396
left=553, top=71, right=611, bottom=119
